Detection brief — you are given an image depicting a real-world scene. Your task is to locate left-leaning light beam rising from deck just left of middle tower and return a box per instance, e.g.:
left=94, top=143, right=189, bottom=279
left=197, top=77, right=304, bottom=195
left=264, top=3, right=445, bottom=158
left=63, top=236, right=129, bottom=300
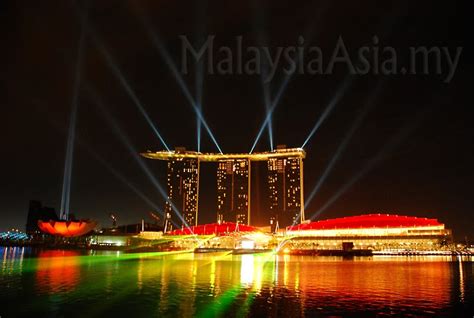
left=136, top=13, right=223, bottom=153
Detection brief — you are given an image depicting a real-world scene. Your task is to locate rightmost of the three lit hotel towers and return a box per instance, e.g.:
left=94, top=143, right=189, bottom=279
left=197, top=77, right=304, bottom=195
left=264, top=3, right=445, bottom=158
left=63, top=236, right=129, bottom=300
left=268, top=147, right=304, bottom=226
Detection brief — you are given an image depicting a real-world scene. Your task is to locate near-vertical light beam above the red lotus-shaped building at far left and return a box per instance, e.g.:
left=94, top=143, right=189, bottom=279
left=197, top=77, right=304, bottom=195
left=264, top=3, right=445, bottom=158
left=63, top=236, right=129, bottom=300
left=59, top=8, right=87, bottom=220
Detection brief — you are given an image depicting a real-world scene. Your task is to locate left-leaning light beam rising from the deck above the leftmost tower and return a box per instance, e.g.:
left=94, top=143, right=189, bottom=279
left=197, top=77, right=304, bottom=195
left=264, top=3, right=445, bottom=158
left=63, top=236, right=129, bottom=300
left=83, top=19, right=170, bottom=151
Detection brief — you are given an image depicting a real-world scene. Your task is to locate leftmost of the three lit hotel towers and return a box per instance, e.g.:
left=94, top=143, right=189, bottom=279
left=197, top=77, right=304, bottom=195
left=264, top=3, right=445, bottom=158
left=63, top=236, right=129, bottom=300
left=165, top=148, right=199, bottom=226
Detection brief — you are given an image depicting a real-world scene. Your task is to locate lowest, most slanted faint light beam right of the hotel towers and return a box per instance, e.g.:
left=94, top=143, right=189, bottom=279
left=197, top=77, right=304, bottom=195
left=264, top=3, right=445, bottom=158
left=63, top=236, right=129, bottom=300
left=310, top=109, right=423, bottom=220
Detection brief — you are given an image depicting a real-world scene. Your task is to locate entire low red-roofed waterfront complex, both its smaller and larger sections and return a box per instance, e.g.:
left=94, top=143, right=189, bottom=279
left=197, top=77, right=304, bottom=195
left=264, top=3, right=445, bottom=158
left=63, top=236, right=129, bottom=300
left=167, top=214, right=452, bottom=255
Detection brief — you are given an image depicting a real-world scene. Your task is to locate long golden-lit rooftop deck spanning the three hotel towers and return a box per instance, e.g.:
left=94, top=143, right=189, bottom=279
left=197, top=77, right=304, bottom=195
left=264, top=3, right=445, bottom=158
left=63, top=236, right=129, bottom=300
left=141, top=148, right=306, bottom=161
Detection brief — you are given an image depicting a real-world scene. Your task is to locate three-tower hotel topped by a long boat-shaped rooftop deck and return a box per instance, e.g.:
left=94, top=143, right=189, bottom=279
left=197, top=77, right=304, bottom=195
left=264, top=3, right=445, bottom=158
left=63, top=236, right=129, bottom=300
left=141, top=146, right=306, bottom=227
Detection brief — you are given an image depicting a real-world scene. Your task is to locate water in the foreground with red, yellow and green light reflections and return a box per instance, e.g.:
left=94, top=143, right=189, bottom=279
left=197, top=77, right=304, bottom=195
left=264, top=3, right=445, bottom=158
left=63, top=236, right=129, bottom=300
left=0, top=247, right=474, bottom=317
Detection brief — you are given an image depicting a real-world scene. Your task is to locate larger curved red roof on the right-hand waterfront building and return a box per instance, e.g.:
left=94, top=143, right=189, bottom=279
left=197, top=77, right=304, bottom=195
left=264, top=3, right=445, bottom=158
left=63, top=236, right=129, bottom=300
left=287, top=214, right=443, bottom=231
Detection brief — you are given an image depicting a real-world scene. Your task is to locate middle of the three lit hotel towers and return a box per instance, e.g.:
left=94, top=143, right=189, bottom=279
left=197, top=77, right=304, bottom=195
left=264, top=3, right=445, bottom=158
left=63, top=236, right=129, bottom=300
left=217, top=159, right=250, bottom=224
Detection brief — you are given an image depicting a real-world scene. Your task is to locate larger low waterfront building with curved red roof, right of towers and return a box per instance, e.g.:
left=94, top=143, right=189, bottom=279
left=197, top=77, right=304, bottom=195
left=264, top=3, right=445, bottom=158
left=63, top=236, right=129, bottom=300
left=286, top=214, right=452, bottom=251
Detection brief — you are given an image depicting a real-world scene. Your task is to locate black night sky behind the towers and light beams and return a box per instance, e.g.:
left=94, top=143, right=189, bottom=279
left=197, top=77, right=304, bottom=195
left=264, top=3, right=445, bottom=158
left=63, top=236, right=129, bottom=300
left=0, top=0, right=474, bottom=239
